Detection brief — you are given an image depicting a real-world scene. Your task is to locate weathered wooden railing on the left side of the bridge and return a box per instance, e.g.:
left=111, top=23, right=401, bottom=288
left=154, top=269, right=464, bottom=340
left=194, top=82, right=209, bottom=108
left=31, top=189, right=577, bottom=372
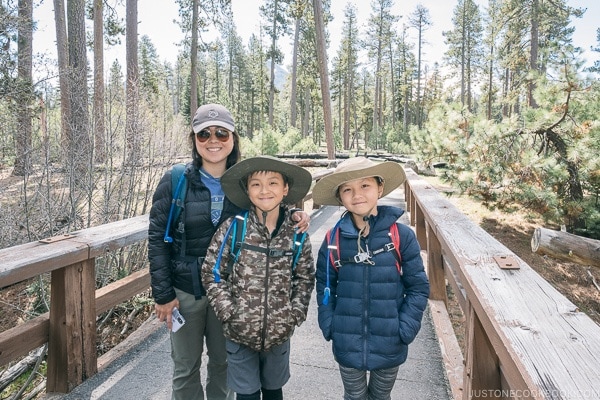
left=0, top=170, right=332, bottom=393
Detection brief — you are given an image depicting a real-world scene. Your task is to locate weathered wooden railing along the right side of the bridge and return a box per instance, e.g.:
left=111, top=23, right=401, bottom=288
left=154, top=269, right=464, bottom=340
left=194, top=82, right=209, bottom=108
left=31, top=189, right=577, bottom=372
left=405, top=171, right=600, bottom=399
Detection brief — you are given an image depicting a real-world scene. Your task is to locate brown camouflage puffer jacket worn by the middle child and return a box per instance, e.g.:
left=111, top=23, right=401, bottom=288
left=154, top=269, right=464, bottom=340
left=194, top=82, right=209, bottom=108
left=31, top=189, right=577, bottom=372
left=202, top=206, right=315, bottom=351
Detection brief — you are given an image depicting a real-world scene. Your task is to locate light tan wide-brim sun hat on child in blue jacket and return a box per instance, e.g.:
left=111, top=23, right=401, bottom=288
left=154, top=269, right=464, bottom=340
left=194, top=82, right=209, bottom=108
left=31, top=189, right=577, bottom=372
left=313, top=157, right=406, bottom=206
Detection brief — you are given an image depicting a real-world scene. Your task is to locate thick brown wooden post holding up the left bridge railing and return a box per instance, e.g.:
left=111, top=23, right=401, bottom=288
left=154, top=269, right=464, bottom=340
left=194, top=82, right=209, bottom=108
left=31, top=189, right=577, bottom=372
left=46, top=259, right=97, bottom=393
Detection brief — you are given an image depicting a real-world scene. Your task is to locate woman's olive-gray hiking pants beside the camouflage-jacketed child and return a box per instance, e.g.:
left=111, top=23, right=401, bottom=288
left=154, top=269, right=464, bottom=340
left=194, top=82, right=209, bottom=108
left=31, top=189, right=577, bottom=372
left=171, top=289, right=234, bottom=400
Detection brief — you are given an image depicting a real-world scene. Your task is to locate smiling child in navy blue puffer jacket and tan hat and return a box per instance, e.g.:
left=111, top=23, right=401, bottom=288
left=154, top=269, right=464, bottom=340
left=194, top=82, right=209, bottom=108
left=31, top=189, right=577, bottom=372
left=313, top=157, right=429, bottom=400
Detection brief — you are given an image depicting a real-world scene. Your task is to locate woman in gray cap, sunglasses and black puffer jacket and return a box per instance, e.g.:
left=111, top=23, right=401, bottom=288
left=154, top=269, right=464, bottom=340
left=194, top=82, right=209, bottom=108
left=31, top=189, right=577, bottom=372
left=148, top=104, right=308, bottom=400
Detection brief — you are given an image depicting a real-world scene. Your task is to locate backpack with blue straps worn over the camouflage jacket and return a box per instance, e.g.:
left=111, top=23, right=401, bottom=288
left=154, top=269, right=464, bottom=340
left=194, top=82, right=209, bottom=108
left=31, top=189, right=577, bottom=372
left=213, top=211, right=306, bottom=283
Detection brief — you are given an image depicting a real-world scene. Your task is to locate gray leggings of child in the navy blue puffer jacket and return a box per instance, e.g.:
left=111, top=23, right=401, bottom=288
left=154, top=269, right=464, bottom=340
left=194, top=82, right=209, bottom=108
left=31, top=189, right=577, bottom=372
left=340, top=365, right=399, bottom=400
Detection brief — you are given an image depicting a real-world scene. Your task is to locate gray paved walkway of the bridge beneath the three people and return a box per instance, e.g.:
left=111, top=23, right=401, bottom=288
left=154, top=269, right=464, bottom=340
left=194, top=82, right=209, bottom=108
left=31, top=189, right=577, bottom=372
left=55, top=190, right=451, bottom=400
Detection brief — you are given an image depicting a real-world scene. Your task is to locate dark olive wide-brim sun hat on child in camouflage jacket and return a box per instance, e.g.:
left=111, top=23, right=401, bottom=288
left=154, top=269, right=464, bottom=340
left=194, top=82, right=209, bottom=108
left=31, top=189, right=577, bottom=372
left=221, top=156, right=312, bottom=210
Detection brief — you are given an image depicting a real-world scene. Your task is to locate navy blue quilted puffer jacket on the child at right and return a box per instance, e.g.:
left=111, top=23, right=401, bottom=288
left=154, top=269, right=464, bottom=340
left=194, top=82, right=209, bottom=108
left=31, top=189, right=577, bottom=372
left=317, top=206, right=429, bottom=371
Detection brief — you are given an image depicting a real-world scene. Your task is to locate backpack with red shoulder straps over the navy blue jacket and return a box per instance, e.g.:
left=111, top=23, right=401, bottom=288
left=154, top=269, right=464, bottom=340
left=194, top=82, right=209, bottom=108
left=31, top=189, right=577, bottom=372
left=323, top=218, right=402, bottom=305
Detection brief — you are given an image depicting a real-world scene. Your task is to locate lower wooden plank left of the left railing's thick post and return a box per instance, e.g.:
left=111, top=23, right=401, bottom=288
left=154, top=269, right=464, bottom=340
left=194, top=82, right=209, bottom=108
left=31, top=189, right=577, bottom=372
left=0, top=313, right=50, bottom=366
